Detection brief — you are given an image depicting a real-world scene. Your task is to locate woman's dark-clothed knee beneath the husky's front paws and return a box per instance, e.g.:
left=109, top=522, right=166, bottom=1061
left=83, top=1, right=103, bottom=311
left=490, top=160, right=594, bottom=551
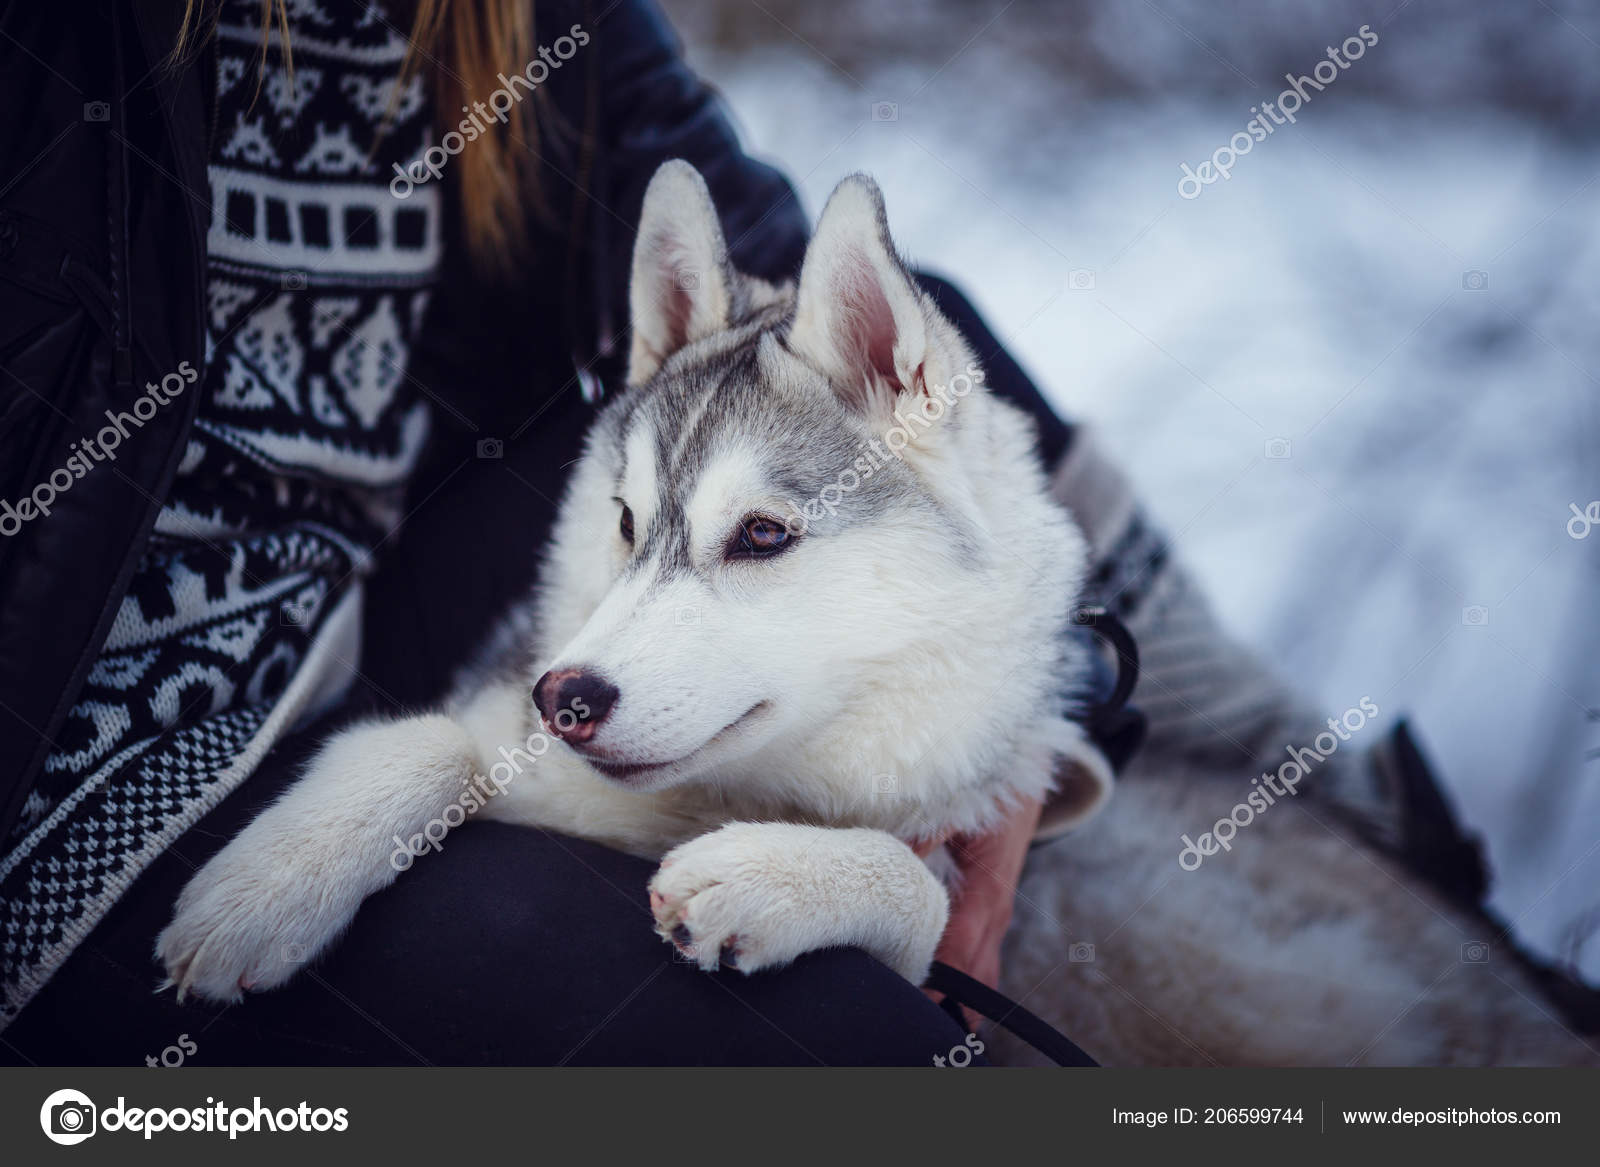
left=308, top=823, right=963, bottom=1065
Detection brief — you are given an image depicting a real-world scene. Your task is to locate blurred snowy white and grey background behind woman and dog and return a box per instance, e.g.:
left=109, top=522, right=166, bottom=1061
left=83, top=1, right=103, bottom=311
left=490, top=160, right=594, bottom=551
left=662, top=0, right=1600, bottom=985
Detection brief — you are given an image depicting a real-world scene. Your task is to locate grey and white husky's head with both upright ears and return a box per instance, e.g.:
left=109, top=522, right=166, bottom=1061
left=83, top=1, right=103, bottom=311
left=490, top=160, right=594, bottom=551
left=534, top=162, right=1075, bottom=806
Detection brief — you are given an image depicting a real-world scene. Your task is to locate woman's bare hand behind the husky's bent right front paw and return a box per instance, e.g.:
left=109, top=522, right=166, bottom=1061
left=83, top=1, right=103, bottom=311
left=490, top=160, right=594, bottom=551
left=934, top=800, right=1045, bottom=1025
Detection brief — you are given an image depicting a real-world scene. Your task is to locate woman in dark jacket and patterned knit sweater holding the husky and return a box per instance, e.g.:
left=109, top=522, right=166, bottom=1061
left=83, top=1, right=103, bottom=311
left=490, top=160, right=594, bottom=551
left=0, top=0, right=1126, bottom=1065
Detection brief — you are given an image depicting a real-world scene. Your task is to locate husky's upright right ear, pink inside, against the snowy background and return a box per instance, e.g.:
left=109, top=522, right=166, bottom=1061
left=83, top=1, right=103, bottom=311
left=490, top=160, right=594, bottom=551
left=789, top=174, right=928, bottom=413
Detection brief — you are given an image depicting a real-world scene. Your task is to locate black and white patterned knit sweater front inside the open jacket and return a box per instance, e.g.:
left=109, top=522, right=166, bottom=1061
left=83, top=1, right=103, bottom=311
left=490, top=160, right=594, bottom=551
left=0, top=0, right=440, bottom=1026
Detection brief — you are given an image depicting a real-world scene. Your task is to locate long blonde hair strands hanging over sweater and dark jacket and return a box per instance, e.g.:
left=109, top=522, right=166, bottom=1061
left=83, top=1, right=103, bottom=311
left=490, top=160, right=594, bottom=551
left=168, top=0, right=544, bottom=271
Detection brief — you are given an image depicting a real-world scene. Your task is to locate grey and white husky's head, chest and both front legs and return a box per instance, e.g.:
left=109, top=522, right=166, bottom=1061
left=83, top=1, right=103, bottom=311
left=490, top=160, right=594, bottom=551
left=157, top=162, right=1110, bottom=999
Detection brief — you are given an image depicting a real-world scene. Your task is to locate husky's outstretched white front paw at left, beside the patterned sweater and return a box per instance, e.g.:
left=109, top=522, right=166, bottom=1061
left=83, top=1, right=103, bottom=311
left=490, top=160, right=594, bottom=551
left=155, top=832, right=354, bottom=1002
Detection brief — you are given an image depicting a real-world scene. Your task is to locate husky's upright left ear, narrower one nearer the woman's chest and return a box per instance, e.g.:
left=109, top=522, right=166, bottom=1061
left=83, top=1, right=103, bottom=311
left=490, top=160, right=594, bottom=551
left=627, top=158, right=733, bottom=386
